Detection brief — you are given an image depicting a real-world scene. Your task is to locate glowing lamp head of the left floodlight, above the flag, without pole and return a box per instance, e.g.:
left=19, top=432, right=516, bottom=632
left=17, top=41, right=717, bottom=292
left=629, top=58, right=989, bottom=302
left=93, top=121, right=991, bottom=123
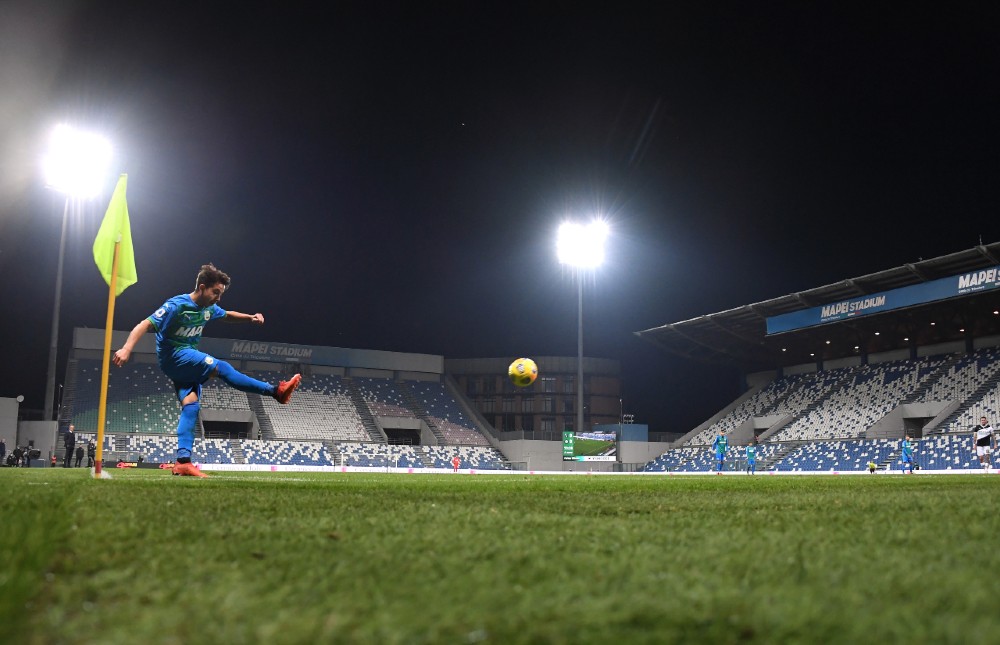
left=42, top=124, right=111, bottom=199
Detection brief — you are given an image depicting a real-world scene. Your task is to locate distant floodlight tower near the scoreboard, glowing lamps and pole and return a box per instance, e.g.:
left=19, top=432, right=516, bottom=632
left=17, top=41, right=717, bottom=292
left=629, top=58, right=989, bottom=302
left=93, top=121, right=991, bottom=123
left=556, top=219, right=608, bottom=432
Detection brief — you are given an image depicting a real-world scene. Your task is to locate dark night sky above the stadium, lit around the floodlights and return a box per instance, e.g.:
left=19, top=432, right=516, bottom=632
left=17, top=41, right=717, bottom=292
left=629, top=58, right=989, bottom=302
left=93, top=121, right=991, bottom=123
left=0, top=1, right=1000, bottom=431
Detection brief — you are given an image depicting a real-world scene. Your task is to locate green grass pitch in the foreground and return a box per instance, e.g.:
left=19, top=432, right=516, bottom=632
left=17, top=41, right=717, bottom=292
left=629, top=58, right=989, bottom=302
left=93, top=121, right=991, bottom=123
left=0, top=468, right=1000, bottom=643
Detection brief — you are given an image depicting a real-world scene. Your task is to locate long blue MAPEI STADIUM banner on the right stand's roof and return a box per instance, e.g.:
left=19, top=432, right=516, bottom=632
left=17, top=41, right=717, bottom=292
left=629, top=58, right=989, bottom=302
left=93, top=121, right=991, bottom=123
left=767, top=266, right=1000, bottom=335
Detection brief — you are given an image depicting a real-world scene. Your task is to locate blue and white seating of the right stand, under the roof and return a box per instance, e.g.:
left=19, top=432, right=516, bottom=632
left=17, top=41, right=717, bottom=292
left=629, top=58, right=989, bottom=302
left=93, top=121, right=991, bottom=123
left=641, top=347, right=1000, bottom=472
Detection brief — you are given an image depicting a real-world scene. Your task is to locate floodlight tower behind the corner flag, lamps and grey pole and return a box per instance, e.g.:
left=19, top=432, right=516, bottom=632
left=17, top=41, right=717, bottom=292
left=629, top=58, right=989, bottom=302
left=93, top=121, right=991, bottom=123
left=42, top=124, right=111, bottom=419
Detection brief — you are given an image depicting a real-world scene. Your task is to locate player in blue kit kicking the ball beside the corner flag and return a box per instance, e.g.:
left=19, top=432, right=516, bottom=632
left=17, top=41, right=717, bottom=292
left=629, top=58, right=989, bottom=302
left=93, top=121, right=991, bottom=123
left=112, top=264, right=302, bottom=477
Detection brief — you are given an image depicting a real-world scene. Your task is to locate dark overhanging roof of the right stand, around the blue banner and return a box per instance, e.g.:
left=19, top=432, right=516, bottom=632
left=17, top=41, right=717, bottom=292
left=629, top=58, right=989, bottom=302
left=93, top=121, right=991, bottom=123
left=635, top=242, right=1000, bottom=371
